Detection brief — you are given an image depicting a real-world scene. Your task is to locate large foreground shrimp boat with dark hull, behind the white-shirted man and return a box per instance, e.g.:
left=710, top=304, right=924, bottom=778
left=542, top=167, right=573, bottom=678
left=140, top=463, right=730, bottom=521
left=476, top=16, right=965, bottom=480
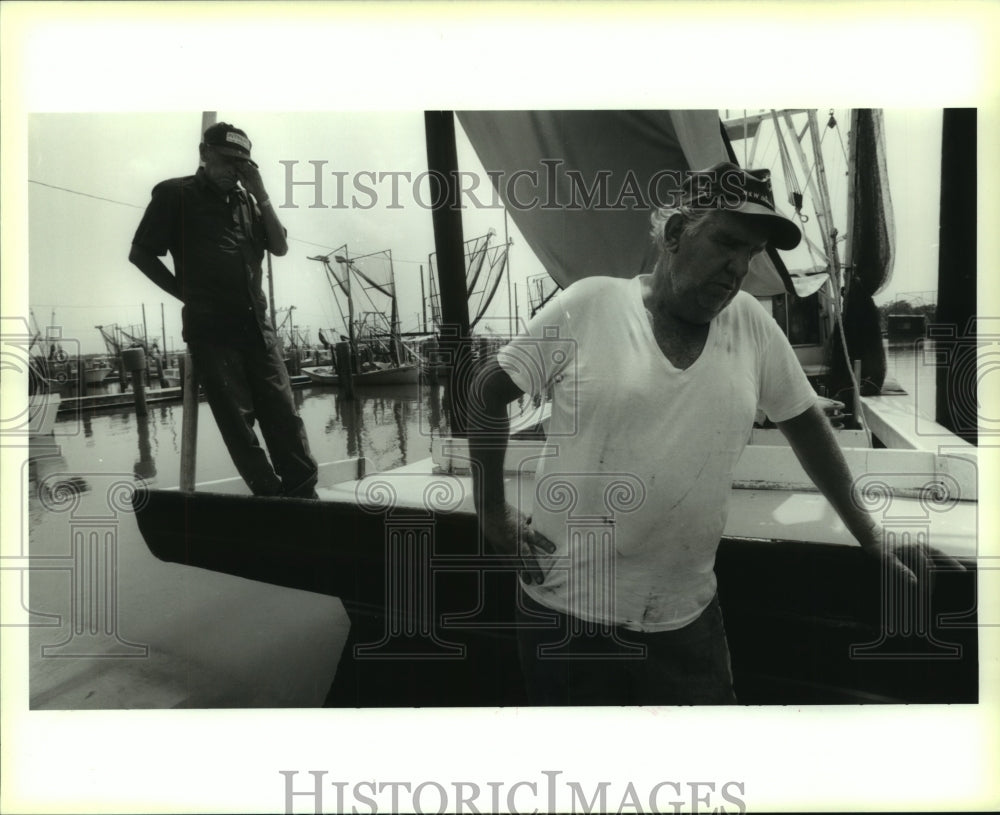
left=134, top=111, right=979, bottom=707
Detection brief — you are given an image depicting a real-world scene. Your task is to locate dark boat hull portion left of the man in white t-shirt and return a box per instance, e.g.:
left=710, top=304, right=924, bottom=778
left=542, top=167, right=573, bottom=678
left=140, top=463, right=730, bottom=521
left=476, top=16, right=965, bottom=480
left=133, top=490, right=527, bottom=707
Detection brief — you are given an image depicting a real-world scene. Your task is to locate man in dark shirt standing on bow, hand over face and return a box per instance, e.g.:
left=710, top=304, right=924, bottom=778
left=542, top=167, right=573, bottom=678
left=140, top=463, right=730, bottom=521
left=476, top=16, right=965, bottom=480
left=129, top=122, right=316, bottom=498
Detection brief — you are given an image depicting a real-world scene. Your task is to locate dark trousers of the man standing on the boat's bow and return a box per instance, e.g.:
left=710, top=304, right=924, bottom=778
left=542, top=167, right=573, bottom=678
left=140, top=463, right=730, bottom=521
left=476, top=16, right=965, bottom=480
left=189, top=342, right=316, bottom=498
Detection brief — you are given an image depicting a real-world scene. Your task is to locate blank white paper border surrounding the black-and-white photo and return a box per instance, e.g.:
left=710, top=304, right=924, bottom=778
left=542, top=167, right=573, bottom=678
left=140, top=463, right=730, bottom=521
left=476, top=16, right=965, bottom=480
left=0, top=2, right=1000, bottom=813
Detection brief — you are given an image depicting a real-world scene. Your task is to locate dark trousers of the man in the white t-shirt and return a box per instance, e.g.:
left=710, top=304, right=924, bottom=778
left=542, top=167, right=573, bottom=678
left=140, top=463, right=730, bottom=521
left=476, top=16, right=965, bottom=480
left=517, top=591, right=736, bottom=705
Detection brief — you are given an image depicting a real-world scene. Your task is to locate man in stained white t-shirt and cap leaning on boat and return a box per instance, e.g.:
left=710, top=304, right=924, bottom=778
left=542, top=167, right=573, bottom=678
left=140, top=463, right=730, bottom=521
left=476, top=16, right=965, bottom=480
left=469, top=163, right=928, bottom=705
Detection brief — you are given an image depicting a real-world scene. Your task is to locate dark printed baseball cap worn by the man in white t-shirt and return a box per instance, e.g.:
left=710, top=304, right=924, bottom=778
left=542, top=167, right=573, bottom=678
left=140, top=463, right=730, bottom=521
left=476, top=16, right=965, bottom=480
left=682, top=161, right=802, bottom=249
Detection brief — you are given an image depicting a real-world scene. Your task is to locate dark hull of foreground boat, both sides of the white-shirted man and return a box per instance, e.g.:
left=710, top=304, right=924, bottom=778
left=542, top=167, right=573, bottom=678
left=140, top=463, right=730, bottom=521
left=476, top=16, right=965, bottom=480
left=134, top=482, right=978, bottom=707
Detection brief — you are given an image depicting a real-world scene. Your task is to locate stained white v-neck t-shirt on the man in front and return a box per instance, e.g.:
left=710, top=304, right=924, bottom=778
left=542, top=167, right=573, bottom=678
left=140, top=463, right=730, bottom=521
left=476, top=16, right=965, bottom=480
left=498, top=277, right=816, bottom=631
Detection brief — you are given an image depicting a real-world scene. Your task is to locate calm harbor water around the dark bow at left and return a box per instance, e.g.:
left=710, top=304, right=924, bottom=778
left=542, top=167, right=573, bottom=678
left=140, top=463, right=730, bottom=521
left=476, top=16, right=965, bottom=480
left=23, top=385, right=447, bottom=709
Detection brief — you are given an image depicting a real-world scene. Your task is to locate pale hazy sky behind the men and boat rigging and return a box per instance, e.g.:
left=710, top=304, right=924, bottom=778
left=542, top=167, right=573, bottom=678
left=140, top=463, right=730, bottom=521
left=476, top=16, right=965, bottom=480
left=27, top=108, right=941, bottom=353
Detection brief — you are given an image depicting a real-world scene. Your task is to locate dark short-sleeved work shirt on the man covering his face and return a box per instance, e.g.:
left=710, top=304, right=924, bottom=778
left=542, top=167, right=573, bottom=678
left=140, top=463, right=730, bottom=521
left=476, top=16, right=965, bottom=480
left=132, top=169, right=275, bottom=347
